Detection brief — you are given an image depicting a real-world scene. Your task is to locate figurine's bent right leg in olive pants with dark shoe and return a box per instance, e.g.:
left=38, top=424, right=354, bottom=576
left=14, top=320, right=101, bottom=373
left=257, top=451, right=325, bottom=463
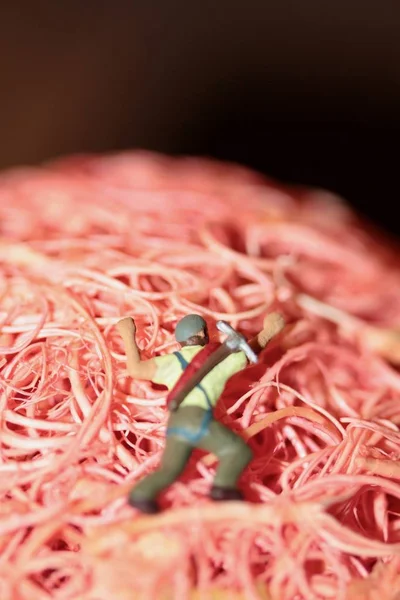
left=197, top=419, right=253, bottom=500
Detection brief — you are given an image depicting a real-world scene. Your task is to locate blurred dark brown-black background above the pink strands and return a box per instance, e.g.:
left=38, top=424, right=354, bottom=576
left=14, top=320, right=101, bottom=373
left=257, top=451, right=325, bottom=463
left=0, top=0, right=400, bottom=234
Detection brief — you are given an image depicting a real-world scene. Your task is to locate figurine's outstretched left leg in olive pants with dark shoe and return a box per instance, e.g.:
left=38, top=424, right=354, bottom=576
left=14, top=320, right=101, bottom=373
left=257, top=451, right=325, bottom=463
left=129, top=435, right=193, bottom=513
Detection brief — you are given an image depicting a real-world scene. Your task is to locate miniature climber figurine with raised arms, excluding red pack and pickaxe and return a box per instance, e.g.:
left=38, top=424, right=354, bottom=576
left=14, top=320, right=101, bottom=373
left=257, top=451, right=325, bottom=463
left=117, top=313, right=284, bottom=514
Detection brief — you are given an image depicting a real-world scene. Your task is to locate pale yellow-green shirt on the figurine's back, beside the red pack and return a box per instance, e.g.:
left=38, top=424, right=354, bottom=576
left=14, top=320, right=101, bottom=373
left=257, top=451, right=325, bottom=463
left=153, top=346, right=247, bottom=408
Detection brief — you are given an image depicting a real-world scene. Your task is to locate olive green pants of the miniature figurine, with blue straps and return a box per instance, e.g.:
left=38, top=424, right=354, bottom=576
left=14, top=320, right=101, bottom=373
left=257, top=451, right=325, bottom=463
left=130, top=406, right=253, bottom=500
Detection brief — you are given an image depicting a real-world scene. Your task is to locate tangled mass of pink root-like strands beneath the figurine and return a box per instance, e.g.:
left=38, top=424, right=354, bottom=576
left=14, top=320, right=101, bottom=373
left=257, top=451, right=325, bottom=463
left=0, top=153, right=400, bottom=600
